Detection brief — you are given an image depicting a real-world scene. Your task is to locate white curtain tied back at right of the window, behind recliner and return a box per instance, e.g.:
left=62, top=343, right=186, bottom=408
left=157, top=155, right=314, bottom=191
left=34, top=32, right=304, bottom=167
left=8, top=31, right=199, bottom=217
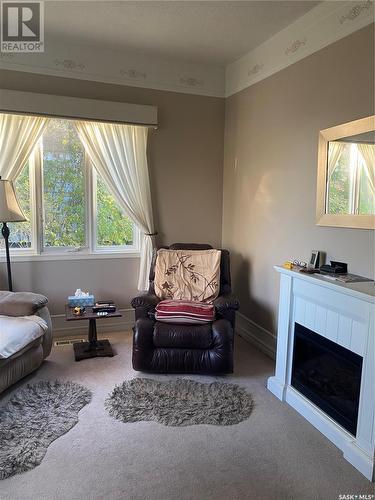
left=75, top=121, right=155, bottom=290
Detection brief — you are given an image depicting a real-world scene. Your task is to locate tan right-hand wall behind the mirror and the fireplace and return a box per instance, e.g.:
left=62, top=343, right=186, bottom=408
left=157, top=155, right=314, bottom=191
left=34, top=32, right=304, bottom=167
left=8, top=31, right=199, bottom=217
left=223, top=25, right=374, bottom=331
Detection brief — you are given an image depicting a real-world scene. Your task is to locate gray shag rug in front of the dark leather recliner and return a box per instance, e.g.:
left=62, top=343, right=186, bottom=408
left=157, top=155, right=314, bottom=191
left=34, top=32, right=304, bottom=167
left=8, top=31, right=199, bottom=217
left=105, top=378, right=254, bottom=426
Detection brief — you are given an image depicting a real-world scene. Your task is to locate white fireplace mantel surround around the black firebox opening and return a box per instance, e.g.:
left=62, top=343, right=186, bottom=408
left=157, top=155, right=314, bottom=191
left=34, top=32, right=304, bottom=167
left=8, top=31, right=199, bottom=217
left=267, top=266, right=375, bottom=481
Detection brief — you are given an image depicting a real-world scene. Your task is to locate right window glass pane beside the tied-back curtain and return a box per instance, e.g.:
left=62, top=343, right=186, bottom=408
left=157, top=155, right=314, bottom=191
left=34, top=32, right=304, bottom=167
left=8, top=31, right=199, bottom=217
left=96, top=177, right=134, bottom=247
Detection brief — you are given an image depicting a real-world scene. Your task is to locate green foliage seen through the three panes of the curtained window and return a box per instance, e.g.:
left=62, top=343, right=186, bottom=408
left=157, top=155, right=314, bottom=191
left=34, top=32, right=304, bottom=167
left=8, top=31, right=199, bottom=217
left=0, top=119, right=133, bottom=248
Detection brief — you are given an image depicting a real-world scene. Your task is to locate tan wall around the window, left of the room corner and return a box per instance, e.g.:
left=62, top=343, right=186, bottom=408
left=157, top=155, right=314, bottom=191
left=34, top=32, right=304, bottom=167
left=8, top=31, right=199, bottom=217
left=0, top=71, right=224, bottom=314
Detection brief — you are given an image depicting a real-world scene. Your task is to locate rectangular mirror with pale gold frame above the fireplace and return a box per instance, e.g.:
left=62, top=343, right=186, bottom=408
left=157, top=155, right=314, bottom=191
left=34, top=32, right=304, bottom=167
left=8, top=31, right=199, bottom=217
left=316, top=115, right=375, bottom=229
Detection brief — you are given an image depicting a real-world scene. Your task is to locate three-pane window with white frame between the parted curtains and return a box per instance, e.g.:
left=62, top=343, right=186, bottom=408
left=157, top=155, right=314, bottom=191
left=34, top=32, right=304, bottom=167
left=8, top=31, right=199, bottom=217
left=0, top=119, right=138, bottom=255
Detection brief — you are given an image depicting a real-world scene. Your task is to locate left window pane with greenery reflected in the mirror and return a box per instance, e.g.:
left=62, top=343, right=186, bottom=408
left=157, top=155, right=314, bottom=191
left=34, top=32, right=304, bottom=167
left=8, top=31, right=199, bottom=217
left=327, top=145, right=350, bottom=214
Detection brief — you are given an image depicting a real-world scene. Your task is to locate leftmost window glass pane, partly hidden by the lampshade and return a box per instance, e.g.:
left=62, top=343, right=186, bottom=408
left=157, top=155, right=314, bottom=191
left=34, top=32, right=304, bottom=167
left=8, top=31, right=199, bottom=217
left=0, top=163, right=32, bottom=248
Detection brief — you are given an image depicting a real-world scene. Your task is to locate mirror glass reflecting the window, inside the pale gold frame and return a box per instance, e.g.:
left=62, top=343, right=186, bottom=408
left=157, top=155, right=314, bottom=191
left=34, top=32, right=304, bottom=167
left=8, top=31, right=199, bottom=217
left=325, top=131, right=375, bottom=215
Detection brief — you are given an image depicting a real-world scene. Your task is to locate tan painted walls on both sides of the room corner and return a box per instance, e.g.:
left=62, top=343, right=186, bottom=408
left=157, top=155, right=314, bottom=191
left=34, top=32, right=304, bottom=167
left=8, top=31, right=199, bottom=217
left=0, top=27, right=374, bottom=330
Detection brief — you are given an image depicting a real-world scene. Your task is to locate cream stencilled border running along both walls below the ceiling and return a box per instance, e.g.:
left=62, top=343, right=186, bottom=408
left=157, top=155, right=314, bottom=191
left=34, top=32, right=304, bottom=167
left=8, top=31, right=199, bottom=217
left=0, top=0, right=374, bottom=97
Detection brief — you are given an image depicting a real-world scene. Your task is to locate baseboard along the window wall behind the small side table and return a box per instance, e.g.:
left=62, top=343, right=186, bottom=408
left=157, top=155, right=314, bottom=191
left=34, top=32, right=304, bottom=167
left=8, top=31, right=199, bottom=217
left=51, top=309, right=134, bottom=338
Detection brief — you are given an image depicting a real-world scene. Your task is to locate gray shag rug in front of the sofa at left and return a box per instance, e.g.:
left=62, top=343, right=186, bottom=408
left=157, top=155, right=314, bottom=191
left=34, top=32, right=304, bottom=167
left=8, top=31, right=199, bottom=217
left=0, top=380, right=91, bottom=479
